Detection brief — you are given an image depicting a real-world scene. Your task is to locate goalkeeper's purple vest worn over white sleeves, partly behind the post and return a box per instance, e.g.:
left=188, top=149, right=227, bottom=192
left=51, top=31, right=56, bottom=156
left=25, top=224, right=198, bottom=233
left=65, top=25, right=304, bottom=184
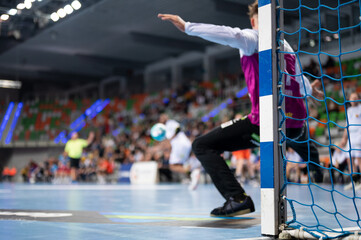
left=241, top=53, right=306, bottom=128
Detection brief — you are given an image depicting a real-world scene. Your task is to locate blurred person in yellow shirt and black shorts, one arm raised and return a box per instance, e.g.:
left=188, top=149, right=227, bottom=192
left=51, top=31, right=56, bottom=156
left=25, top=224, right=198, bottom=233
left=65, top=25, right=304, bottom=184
left=64, top=132, right=94, bottom=182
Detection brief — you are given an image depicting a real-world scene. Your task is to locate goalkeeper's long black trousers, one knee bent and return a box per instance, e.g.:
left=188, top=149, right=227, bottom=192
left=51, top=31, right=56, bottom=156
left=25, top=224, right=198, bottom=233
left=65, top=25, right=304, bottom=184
left=192, top=118, right=318, bottom=199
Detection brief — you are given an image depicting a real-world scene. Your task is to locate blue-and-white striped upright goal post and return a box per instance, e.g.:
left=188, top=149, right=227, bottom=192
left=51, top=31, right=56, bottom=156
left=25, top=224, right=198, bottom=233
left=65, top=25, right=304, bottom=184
left=258, top=0, right=284, bottom=236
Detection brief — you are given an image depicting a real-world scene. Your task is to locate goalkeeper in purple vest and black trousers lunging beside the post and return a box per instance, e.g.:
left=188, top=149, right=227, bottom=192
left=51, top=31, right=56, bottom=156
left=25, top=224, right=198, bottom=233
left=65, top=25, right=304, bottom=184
left=158, top=1, right=322, bottom=216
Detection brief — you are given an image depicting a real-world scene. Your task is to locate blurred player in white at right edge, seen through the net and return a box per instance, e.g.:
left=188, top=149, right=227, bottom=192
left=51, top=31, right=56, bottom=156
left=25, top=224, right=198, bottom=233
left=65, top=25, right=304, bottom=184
left=340, top=92, right=361, bottom=190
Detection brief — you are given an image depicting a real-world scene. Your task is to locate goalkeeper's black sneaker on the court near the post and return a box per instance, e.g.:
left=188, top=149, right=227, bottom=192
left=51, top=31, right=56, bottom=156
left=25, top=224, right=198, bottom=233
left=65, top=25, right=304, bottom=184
left=211, top=196, right=254, bottom=217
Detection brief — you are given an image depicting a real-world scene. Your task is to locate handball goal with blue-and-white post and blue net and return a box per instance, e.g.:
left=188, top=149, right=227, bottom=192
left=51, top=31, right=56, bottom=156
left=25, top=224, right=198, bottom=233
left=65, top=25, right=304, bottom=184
left=259, top=0, right=361, bottom=239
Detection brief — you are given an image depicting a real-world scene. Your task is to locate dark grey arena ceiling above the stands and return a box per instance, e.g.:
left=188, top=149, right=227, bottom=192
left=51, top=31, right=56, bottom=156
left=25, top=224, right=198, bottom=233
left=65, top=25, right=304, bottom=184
left=0, top=0, right=356, bottom=81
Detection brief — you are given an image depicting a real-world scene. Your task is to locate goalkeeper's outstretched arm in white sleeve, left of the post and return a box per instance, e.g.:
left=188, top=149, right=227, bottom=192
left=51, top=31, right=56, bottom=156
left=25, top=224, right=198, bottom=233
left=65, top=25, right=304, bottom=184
left=158, top=14, right=258, bottom=56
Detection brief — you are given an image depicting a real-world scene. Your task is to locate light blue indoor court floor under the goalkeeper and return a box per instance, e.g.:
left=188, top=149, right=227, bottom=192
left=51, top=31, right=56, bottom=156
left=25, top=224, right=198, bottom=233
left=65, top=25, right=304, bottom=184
left=0, top=183, right=358, bottom=240
